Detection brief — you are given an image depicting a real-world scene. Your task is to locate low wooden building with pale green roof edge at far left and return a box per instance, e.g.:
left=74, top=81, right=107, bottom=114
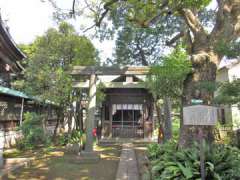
left=0, top=86, right=58, bottom=131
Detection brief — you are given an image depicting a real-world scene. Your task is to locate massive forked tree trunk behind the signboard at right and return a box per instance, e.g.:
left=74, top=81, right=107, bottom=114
left=176, top=0, right=240, bottom=146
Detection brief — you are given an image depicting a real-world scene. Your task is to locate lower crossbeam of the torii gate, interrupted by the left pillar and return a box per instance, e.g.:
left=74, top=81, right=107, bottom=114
left=73, top=81, right=145, bottom=89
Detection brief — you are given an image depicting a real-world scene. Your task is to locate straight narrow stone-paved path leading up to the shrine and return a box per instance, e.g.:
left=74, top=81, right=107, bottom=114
left=116, top=143, right=139, bottom=180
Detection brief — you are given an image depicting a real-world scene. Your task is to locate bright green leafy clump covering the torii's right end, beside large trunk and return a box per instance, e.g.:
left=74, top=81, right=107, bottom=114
left=146, top=48, right=191, bottom=98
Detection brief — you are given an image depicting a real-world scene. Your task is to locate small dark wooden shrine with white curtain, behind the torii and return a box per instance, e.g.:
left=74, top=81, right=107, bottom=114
left=101, top=76, right=153, bottom=138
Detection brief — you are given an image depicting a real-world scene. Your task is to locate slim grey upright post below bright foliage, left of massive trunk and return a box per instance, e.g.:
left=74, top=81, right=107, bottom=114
left=164, top=97, right=172, bottom=141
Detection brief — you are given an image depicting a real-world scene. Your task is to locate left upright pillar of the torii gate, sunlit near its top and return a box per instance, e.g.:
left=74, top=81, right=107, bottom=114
left=85, top=74, right=97, bottom=152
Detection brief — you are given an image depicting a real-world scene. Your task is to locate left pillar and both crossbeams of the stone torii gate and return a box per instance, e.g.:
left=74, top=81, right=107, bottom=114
left=71, top=66, right=150, bottom=153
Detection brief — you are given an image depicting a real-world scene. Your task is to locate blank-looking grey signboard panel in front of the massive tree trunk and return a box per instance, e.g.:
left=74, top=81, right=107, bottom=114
left=183, top=105, right=217, bottom=126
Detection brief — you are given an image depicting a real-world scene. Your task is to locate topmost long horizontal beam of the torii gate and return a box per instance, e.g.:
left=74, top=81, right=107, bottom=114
left=71, top=66, right=150, bottom=75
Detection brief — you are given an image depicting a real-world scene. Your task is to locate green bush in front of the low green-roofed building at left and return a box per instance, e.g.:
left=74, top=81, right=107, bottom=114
left=16, top=112, right=50, bottom=149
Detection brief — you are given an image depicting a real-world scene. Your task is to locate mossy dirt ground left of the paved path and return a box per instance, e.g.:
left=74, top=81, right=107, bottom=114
left=3, top=145, right=121, bottom=180
